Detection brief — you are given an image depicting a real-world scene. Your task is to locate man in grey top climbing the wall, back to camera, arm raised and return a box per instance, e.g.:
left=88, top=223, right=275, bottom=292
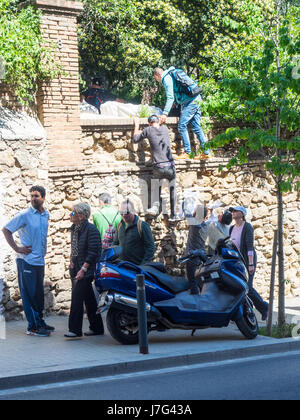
left=132, top=114, right=179, bottom=221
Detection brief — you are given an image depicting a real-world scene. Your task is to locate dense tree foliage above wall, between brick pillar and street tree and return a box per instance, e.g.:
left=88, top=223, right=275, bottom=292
left=79, top=0, right=272, bottom=105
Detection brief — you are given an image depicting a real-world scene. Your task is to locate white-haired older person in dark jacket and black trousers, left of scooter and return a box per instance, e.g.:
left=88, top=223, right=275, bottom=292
left=65, top=203, right=104, bottom=339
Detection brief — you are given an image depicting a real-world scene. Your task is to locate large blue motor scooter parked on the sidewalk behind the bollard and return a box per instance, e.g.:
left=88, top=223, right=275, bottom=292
left=95, top=239, right=258, bottom=344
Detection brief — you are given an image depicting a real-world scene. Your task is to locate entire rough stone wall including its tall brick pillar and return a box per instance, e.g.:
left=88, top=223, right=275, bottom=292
left=0, top=0, right=300, bottom=319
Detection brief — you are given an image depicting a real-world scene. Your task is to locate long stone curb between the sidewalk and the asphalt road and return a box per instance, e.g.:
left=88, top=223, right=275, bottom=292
left=0, top=338, right=300, bottom=390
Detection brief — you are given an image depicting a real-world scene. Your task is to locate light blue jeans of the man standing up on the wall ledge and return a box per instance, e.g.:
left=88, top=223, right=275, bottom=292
left=178, top=96, right=209, bottom=155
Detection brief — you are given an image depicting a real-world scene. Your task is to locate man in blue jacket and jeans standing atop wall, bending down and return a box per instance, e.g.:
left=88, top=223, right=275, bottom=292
left=154, top=67, right=209, bottom=160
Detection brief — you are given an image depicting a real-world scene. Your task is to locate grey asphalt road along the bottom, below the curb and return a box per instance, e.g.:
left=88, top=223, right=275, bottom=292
left=0, top=352, right=300, bottom=402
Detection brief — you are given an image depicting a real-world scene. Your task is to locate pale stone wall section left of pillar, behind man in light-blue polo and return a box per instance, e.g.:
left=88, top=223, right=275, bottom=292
left=0, top=132, right=49, bottom=319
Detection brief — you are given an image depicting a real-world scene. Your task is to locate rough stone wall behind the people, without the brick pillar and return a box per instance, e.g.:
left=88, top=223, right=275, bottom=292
left=0, top=116, right=300, bottom=319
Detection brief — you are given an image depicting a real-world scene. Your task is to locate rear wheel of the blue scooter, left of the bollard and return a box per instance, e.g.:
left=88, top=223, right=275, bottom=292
left=106, top=308, right=139, bottom=345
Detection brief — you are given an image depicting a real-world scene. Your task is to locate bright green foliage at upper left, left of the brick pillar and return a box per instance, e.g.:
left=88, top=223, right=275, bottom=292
left=0, top=0, right=58, bottom=104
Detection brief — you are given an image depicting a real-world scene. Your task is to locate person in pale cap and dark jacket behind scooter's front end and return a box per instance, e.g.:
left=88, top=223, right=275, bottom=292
left=230, top=206, right=269, bottom=321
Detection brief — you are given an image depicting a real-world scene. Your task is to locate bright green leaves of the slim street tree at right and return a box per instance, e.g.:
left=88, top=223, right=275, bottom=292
left=209, top=0, right=300, bottom=192
